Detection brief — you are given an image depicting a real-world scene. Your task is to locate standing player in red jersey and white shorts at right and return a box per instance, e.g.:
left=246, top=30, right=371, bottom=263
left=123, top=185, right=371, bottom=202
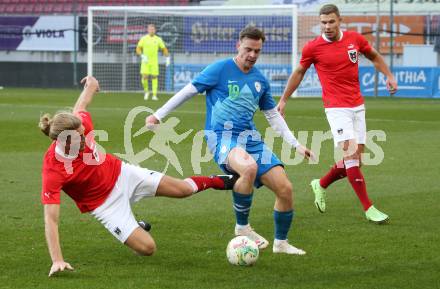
left=278, top=4, right=397, bottom=223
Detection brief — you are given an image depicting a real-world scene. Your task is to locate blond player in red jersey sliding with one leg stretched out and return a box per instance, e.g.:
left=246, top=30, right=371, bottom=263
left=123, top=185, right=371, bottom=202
left=39, top=76, right=235, bottom=276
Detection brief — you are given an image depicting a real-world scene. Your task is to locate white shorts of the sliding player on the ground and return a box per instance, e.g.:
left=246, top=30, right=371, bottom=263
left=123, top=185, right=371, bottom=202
left=91, top=162, right=164, bottom=243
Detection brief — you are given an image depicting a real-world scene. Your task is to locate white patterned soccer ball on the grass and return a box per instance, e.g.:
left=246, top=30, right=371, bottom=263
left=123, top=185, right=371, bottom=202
left=226, top=236, right=260, bottom=266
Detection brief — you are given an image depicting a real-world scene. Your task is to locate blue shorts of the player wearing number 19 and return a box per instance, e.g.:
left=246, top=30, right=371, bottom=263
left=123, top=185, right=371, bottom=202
left=208, top=134, right=284, bottom=188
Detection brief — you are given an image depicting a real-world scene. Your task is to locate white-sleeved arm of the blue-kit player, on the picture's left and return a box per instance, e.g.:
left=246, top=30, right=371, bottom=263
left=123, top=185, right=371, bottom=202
left=145, top=83, right=199, bottom=127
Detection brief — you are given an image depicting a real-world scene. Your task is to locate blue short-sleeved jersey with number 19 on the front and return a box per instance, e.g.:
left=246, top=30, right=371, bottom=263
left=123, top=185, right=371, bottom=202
left=192, top=58, right=276, bottom=133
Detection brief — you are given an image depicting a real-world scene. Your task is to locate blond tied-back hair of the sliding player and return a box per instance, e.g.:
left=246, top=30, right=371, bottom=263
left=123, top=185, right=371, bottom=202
left=38, top=111, right=81, bottom=140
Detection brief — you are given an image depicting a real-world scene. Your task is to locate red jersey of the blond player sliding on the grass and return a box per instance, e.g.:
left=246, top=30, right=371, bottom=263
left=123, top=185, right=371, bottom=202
left=41, top=112, right=121, bottom=213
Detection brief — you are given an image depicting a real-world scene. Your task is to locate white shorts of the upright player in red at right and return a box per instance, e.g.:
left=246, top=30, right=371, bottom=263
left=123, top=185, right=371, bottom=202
left=325, top=104, right=367, bottom=147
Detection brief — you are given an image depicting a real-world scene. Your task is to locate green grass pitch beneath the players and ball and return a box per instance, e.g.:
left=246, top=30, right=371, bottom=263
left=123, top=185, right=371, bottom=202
left=0, top=89, right=440, bottom=289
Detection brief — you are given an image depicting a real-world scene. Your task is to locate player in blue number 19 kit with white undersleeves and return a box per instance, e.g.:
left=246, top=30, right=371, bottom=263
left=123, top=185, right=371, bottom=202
left=146, top=26, right=314, bottom=255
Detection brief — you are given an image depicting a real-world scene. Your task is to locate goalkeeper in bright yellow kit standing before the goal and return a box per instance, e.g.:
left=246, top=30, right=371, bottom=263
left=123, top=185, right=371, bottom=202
left=136, top=24, right=170, bottom=100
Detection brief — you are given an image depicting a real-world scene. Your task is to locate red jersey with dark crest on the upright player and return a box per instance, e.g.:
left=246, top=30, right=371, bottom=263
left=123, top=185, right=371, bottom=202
left=300, top=31, right=371, bottom=108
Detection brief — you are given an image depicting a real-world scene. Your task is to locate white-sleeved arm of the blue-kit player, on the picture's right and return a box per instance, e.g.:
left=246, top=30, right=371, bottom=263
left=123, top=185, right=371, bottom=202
left=263, top=108, right=316, bottom=161
